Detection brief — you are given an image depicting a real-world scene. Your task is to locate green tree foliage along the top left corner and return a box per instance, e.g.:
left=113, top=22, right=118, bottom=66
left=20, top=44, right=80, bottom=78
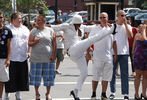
left=0, top=0, right=48, bottom=13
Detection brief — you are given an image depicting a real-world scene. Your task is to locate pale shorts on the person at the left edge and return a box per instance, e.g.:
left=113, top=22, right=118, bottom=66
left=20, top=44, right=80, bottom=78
left=0, top=59, right=9, bottom=82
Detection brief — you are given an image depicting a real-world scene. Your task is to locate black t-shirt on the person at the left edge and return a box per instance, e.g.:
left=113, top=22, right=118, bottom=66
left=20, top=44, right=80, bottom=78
left=0, top=26, right=13, bottom=59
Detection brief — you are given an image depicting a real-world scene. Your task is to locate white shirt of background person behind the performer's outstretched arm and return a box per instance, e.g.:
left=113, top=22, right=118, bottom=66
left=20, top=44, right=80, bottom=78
left=55, top=31, right=64, bottom=49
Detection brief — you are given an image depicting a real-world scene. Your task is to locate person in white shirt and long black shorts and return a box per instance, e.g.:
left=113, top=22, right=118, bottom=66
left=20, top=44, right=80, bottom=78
left=5, top=13, right=30, bottom=100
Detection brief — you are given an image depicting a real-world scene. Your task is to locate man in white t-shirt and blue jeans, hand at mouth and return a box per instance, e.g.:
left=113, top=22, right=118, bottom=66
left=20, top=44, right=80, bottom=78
left=109, top=10, right=133, bottom=100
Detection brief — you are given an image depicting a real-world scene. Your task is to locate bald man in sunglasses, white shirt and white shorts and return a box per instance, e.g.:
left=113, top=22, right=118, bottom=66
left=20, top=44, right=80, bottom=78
left=89, top=12, right=117, bottom=100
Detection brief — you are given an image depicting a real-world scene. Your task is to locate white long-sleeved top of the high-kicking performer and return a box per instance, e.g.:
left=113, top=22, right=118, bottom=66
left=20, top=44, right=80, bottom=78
left=51, top=23, right=93, bottom=50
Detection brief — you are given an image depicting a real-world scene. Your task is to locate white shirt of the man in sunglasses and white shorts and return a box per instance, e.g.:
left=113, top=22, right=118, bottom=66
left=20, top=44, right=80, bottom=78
left=89, top=25, right=115, bottom=62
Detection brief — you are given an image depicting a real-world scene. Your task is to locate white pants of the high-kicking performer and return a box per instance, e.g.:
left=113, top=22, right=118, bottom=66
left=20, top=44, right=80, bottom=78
left=68, top=27, right=114, bottom=90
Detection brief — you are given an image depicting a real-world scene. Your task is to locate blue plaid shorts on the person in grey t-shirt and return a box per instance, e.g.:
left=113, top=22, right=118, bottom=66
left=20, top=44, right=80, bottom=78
left=29, top=62, right=55, bottom=86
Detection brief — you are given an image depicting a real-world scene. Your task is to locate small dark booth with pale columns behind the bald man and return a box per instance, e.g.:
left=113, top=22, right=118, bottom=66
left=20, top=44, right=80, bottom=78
left=83, top=0, right=120, bottom=21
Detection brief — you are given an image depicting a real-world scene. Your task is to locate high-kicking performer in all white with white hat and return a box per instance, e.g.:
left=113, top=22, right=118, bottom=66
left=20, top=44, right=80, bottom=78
left=51, top=15, right=114, bottom=100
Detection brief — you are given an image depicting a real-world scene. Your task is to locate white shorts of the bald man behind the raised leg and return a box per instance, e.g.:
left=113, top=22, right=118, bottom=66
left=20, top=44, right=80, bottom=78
left=92, top=60, right=113, bottom=81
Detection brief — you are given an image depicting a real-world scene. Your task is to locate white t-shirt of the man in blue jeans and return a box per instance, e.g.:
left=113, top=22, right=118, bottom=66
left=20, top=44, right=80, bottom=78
left=116, top=24, right=132, bottom=55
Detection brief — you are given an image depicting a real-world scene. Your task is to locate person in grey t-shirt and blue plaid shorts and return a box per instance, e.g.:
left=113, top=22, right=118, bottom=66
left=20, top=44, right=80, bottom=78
left=28, top=14, right=56, bottom=100
